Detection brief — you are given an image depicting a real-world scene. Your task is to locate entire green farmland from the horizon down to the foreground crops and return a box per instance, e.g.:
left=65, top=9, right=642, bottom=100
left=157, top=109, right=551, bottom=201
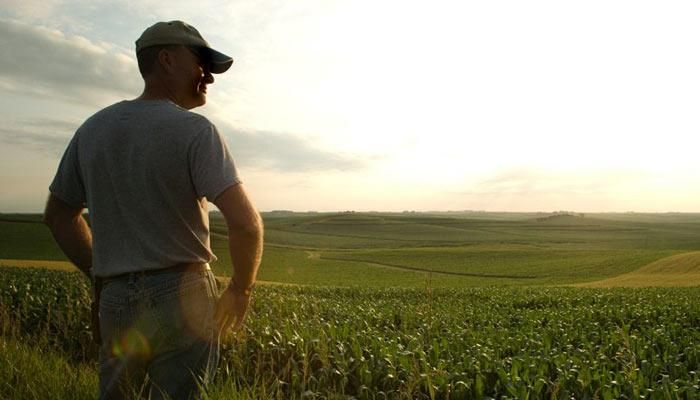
left=0, top=212, right=700, bottom=399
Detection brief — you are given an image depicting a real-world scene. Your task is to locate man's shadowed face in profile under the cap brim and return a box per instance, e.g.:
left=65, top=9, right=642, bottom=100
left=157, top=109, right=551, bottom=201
left=174, top=46, right=214, bottom=110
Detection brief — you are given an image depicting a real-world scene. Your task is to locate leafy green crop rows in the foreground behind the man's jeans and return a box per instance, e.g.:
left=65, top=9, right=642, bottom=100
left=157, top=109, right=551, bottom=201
left=0, top=268, right=700, bottom=399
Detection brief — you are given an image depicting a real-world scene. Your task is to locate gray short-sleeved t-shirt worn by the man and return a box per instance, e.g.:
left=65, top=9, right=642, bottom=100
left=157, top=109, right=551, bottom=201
left=49, top=100, right=240, bottom=277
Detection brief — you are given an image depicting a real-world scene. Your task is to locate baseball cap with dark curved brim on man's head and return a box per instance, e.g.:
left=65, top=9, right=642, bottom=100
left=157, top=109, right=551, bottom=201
left=136, top=21, right=233, bottom=74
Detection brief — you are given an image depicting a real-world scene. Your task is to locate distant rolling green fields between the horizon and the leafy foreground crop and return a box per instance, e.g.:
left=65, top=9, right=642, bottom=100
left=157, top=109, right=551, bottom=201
left=0, top=212, right=700, bottom=287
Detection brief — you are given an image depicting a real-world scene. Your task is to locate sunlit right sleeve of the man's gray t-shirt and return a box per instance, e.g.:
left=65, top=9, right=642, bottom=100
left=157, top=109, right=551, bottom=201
left=189, top=124, right=241, bottom=201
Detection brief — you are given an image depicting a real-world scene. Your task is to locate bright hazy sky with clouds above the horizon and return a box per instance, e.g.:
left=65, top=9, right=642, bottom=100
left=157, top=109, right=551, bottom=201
left=0, top=0, right=700, bottom=212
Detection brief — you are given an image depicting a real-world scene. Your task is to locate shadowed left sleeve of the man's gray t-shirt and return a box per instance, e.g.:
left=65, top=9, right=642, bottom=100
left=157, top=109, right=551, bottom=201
left=49, top=133, right=87, bottom=208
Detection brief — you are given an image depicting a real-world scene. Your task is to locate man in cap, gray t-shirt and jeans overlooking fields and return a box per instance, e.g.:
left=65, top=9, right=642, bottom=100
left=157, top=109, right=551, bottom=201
left=44, top=21, right=262, bottom=399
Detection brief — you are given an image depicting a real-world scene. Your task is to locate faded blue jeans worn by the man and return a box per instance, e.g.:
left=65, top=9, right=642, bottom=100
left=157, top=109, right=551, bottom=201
left=99, top=269, right=219, bottom=399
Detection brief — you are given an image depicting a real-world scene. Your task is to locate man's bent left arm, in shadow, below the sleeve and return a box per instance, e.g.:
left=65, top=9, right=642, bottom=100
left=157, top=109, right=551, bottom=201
left=44, top=194, right=92, bottom=278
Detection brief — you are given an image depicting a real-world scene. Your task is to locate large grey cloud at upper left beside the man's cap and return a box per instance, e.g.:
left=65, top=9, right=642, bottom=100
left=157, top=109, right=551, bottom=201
left=0, top=19, right=142, bottom=103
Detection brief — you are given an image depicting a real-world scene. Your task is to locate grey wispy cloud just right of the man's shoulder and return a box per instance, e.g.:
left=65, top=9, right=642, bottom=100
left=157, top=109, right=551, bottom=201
left=217, top=123, right=373, bottom=172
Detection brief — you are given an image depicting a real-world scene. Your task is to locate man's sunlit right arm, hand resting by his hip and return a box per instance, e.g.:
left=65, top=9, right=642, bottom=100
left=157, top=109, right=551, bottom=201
left=213, top=184, right=263, bottom=332
